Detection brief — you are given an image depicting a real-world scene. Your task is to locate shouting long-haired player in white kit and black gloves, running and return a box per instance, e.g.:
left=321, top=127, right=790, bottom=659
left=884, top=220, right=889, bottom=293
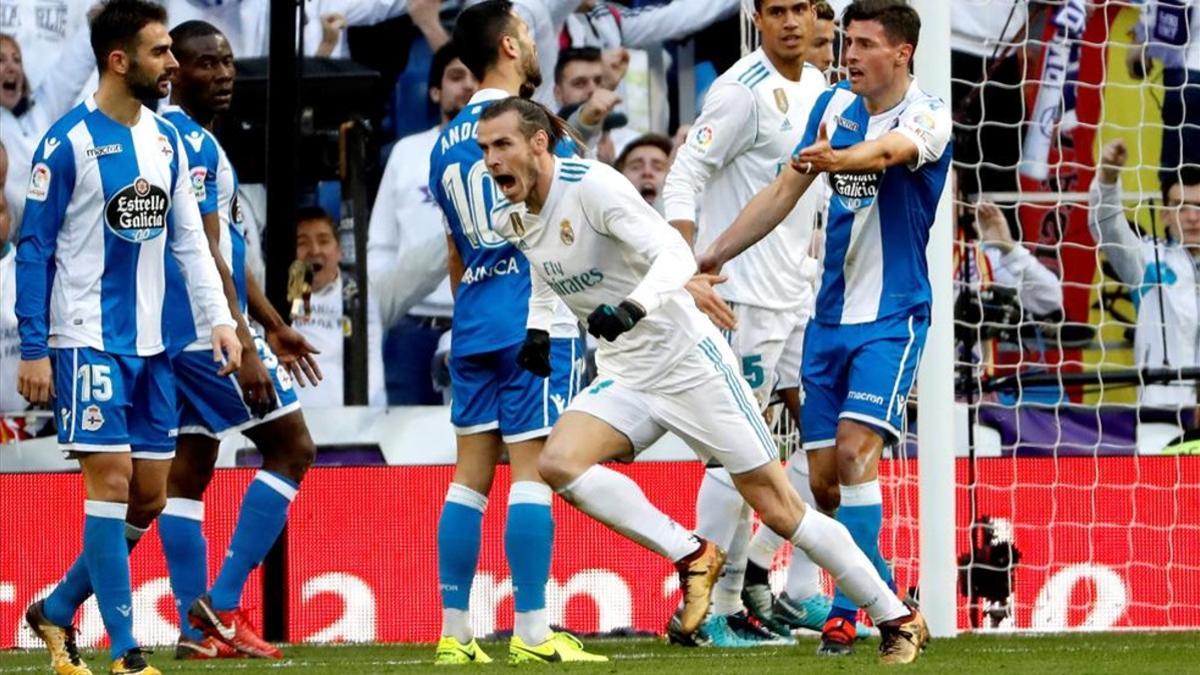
left=478, top=97, right=928, bottom=662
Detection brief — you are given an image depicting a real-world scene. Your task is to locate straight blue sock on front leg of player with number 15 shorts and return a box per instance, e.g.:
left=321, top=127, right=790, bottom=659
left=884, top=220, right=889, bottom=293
left=83, top=500, right=138, bottom=659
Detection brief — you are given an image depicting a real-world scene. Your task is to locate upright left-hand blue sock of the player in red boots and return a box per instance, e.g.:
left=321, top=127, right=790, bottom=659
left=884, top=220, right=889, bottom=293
left=158, top=497, right=209, bottom=641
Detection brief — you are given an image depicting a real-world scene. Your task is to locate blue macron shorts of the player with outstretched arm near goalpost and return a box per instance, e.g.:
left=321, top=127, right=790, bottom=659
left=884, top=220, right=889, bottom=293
left=800, top=315, right=929, bottom=450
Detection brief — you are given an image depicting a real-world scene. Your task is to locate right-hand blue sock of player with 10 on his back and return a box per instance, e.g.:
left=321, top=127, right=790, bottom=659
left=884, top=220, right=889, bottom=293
left=504, top=480, right=554, bottom=613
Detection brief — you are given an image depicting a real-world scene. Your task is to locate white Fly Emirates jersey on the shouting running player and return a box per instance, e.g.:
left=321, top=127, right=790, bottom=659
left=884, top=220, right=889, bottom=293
left=492, top=157, right=721, bottom=392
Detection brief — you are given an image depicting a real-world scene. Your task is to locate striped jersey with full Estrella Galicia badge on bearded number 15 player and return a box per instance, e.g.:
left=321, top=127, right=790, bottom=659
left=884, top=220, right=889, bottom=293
left=17, top=97, right=233, bottom=360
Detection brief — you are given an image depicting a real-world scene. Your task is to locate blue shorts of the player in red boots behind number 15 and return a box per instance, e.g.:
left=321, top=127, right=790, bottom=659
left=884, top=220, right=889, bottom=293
left=170, top=335, right=300, bottom=438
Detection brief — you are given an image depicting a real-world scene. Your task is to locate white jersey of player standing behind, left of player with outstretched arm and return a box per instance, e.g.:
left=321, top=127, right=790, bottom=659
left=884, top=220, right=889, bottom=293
left=662, top=48, right=827, bottom=310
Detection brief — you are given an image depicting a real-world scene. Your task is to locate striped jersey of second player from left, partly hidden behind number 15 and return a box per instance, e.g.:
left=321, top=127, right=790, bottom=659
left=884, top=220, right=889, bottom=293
left=162, top=106, right=247, bottom=351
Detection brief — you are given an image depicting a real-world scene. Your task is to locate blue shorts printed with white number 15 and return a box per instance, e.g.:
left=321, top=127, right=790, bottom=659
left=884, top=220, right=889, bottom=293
left=50, top=347, right=177, bottom=460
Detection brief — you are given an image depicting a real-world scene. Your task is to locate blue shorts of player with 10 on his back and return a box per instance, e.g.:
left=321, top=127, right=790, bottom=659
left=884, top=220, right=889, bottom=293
left=450, top=338, right=586, bottom=443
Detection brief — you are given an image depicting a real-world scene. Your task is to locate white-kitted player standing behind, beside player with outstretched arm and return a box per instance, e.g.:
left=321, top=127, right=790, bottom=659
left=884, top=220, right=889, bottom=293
left=662, top=0, right=829, bottom=646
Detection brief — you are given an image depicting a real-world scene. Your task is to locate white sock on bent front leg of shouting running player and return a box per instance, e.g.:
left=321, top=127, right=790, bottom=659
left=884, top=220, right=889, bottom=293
left=558, top=465, right=698, bottom=561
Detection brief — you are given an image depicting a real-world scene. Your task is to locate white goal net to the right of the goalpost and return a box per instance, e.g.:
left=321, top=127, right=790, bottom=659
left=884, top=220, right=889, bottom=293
left=743, top=0, right=1200, bottom=631
